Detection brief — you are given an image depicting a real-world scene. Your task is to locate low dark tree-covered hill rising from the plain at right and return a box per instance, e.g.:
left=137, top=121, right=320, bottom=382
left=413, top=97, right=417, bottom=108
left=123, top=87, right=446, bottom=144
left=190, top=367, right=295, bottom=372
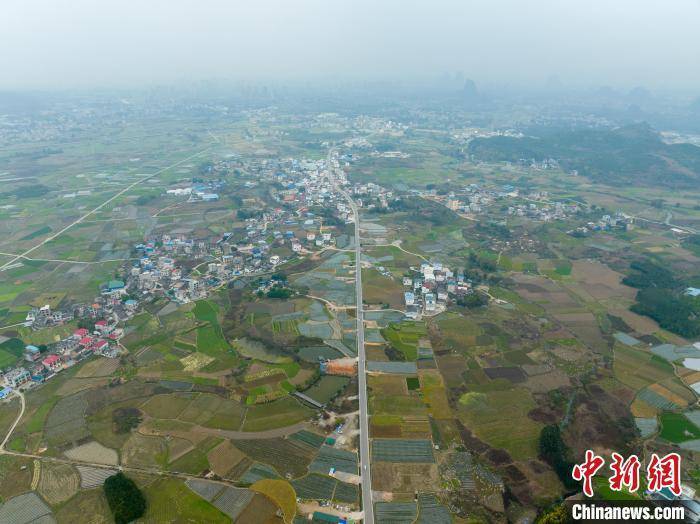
left=469, top=124, right=700, bottom=187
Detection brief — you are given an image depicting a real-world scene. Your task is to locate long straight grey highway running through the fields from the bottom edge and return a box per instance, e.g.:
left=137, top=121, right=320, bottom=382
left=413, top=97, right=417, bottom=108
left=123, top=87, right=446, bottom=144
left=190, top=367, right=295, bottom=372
left=328, top=153, right=374, bottom=524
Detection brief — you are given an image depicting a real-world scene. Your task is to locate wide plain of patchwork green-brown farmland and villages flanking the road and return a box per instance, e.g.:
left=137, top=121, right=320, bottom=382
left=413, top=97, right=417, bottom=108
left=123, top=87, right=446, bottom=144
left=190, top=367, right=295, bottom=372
left=0, top=87, right=700, bottom=524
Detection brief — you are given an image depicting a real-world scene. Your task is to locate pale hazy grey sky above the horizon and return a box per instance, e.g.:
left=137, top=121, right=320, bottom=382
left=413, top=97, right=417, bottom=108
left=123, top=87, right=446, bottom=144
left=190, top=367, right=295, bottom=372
left=0, top=0, right=700, bottom=88
